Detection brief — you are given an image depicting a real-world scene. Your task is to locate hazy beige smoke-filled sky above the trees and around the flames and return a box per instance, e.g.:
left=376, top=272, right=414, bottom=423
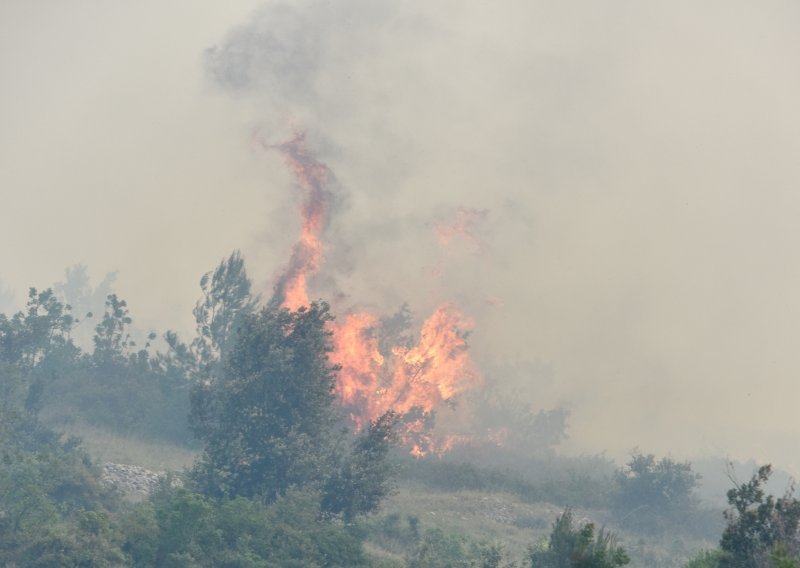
left=0, top=0, right=800, bottom=470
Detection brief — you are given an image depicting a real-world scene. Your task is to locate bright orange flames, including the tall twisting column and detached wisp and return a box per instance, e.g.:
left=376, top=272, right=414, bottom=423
left=262, top=133, right=485, bottom=456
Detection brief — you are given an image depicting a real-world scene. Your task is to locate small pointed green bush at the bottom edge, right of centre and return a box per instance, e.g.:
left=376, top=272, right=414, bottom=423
left=529, top=509, right=630, bottom=568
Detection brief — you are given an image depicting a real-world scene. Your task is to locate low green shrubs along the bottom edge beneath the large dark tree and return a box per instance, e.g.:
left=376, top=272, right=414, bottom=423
left=122, top=486, right=364, bottom=568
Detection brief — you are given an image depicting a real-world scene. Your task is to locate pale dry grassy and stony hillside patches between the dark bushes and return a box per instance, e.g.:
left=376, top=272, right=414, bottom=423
left=69, top=425, right=723, bottom=568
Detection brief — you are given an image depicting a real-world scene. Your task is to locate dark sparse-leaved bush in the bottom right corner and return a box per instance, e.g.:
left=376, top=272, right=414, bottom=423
left=719, top=465, right=800, bottom=568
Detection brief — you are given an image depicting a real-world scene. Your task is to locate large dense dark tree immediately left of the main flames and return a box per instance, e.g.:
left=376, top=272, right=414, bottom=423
left=190, top=303, right=337, bottom=502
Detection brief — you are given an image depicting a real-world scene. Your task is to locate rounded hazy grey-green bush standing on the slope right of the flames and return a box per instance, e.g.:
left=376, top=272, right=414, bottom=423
left=612, top=451, right=700, bottom=533
